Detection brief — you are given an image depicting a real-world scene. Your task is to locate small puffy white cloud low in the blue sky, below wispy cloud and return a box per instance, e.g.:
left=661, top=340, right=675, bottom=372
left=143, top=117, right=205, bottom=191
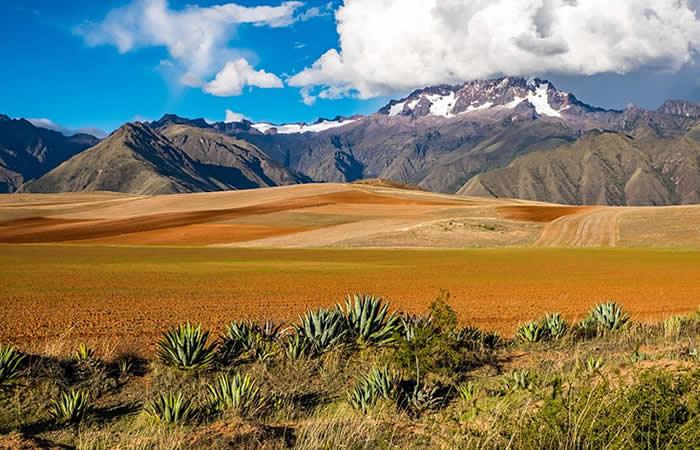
left=204, top=58, right=283, bottom=97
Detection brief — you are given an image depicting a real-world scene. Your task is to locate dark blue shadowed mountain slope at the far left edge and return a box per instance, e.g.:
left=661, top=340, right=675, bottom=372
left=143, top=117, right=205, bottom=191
left=0, top=114, right=98, bottom=193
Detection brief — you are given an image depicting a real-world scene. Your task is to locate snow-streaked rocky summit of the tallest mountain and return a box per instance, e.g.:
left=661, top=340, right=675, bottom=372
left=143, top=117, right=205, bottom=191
left=379, top=77, right=604, bottom=118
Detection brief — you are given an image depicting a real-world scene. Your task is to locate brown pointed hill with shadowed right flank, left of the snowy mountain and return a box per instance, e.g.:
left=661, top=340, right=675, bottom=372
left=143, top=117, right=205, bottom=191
left=23, top=121, right=304, bottom=195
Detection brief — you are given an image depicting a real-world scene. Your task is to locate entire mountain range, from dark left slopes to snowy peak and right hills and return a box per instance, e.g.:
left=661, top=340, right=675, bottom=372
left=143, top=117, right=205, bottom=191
left=6, top=77, right=700, bottom=205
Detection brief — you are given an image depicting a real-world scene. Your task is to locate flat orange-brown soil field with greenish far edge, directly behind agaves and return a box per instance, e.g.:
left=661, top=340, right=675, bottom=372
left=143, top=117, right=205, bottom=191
left=0, top=245, right=700, bottom=351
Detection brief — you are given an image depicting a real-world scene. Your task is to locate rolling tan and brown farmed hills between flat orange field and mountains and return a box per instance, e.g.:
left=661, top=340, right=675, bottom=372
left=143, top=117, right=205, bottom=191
left=0, top=183, right=700, bottom=248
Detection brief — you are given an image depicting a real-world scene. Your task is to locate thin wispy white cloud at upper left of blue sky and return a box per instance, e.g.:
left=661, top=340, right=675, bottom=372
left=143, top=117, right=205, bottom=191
left=76, top=0, right=303, bottom=95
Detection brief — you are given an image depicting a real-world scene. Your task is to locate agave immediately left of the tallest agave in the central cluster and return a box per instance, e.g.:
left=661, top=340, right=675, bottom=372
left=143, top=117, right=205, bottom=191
left=295, top=308, right=348, bottom=353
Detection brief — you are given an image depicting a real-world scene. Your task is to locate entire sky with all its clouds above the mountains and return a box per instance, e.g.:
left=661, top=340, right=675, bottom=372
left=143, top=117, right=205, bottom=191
left=0, top=0, right=700, bottom=133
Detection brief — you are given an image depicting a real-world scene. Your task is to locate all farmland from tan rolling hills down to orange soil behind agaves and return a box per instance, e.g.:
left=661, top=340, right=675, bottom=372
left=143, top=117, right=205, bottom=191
left=0, top=183, right=700, bottom=349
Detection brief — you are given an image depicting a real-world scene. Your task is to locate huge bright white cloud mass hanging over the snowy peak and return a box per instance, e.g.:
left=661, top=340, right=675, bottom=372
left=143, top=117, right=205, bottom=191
left=289, top=0, right=700, bottom=102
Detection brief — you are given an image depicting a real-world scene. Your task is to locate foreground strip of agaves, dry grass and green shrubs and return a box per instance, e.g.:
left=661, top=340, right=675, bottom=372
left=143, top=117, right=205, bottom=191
left=0, top=292, right=700, bottom=449
